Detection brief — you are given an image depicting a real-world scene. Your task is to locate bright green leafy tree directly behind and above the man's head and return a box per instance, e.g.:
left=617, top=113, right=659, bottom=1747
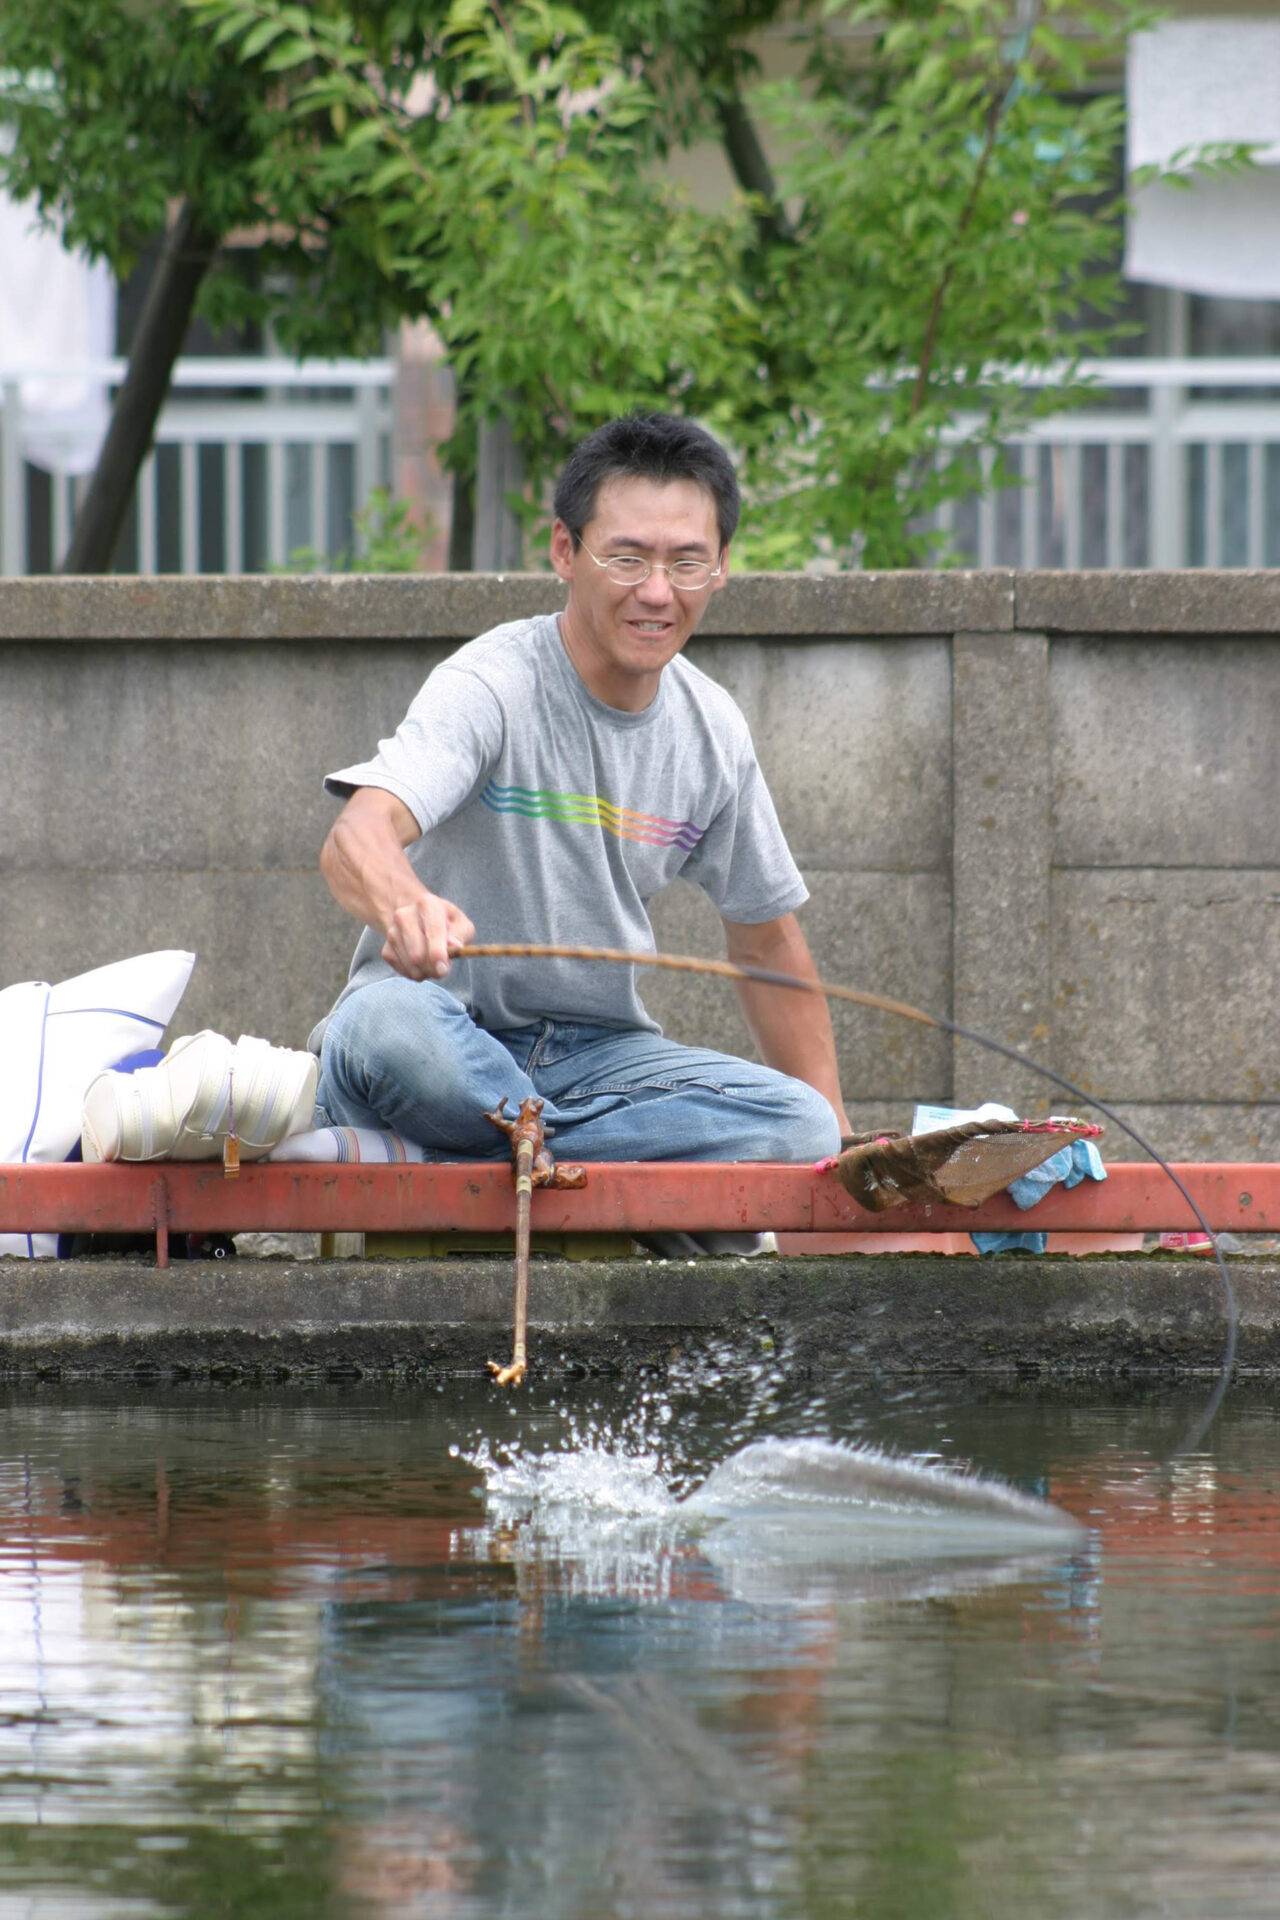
left=188, top=0, right=1238, bottom=566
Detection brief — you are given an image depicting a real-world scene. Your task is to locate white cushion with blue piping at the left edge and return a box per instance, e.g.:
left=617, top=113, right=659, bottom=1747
left=0, top=948, right=196, bottom=1256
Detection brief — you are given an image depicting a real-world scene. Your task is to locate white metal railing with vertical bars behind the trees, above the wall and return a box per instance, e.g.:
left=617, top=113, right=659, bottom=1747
left=0, top=357, right=1280, bottom=574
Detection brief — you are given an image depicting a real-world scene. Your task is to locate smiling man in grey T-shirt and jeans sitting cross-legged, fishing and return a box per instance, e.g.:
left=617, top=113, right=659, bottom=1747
left=311, top=415, right=846, bottom=1162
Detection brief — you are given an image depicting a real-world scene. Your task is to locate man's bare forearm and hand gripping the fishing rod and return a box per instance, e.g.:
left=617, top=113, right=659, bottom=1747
left=320, top=787, right=476, bottom=979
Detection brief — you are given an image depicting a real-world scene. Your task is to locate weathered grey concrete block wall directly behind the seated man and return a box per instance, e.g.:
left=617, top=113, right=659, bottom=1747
left=0, top=572, right=1280, bottom=1158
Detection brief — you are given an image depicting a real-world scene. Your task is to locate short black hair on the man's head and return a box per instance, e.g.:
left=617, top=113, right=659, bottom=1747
left=555, top=413, right=743, bottom=547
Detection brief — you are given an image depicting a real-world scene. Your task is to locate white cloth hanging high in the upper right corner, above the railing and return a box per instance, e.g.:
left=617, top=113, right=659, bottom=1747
left=1125, top=15, right=1280, bottom=300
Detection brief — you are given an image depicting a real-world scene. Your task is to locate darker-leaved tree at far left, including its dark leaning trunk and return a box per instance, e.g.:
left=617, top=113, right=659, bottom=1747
left=0, top=0, right=429, bottom=572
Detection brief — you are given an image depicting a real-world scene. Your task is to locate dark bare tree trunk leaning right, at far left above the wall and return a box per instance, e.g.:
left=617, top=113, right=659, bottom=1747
left=61, top=202, right=217, bottom=574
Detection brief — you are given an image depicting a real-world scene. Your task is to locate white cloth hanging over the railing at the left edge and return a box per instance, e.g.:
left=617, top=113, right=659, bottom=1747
left=0, top=173, right=115, bottom=474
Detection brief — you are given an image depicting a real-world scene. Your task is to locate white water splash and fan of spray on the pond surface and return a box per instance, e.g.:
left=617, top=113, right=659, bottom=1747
left=470, top=1434, right=1086, bottom=1603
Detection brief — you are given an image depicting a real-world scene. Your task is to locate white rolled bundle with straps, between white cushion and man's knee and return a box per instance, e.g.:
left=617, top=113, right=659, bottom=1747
left=81, top=1033, right=320, bottom=1162
